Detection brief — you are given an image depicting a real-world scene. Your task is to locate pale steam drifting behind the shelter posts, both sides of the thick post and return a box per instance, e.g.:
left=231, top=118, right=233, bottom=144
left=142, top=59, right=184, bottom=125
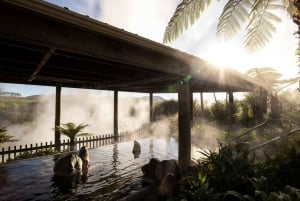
left=4, top=88, right=234, bottom=160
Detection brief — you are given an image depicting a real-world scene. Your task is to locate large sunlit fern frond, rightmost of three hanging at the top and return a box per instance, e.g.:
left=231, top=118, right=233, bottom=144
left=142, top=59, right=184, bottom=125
left=244, top=0, right=284, bottom=51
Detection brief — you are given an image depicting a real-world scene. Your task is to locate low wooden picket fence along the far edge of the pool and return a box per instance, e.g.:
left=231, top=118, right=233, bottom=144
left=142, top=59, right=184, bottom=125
left=0, top=127, right=149, bottom=163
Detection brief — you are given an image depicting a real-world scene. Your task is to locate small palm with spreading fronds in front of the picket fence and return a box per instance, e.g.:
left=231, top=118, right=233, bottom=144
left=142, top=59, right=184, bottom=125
left=55, top=122, right=91, bottom=151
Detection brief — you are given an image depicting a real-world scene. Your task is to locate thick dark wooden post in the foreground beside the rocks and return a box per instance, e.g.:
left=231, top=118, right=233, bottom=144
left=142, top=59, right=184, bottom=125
left=178, top=81, right=191, bottom=174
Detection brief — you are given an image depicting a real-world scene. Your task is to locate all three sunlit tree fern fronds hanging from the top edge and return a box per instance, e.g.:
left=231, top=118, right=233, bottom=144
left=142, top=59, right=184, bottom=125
left=163, top=0, right=291, bottom=51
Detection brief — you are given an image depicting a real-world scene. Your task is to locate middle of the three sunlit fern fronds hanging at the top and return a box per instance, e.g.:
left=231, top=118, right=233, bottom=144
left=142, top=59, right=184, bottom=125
left=217, top=0, right=252, bottom=39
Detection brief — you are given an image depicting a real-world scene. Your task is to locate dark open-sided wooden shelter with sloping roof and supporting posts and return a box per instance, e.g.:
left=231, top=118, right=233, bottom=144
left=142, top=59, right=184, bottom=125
left=0, top=0, right=254, bottom=172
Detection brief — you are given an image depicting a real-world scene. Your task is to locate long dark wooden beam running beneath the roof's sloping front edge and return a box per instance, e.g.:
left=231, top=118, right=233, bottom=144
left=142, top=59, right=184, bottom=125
left=0, top=1, right=188, bottom=75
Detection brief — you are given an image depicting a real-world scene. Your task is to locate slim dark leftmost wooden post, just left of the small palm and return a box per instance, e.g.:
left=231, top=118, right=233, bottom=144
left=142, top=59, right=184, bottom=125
left=54, top=83, right=61, bottom=151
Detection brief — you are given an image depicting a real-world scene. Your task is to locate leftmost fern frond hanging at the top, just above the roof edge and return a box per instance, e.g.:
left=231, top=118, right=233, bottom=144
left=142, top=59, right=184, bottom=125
left=163, top=0, right=211, bottom=43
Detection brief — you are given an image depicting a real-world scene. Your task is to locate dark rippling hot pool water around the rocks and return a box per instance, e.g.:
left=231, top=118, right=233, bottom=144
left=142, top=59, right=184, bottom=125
left=0, top=138, right=178, bottom=201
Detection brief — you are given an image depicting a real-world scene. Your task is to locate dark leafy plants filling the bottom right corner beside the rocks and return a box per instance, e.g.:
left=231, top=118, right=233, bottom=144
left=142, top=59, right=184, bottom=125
left=171, top=139, right=300, bottom=201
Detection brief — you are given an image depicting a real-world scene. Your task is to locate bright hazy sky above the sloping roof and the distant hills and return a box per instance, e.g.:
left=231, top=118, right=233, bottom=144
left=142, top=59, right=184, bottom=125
left=0, top=0, right=299, bottom=96
